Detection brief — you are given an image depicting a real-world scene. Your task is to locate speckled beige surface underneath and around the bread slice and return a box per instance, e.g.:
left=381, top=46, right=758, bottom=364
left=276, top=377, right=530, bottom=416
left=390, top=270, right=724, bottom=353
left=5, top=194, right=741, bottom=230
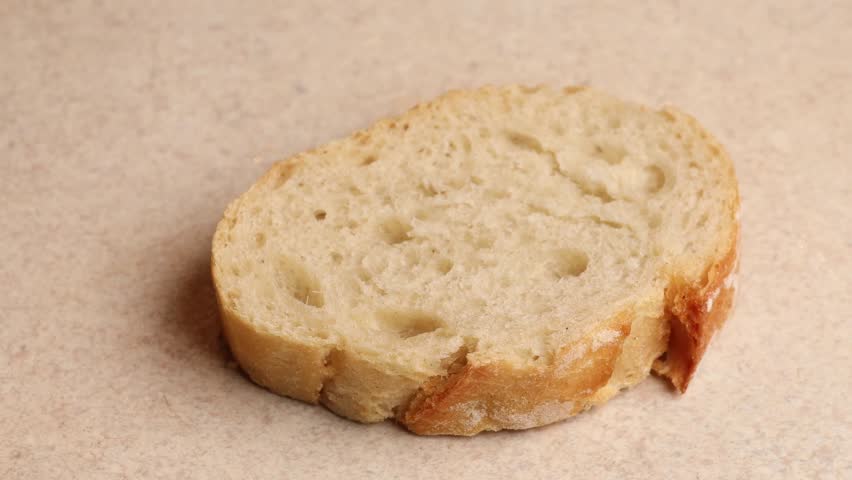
left=0, top=0, right=852, bottom=479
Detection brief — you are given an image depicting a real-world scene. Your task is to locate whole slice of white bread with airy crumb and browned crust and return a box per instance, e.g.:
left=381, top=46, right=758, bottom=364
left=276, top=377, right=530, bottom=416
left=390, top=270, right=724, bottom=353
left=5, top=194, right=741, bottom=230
left=212, top=87, right=739, bottom=435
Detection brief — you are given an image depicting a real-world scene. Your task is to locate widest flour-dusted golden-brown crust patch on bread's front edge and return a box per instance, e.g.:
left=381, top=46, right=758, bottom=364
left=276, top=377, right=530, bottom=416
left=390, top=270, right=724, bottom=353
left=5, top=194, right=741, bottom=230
left=397, top=318, right=633, bottom=435
